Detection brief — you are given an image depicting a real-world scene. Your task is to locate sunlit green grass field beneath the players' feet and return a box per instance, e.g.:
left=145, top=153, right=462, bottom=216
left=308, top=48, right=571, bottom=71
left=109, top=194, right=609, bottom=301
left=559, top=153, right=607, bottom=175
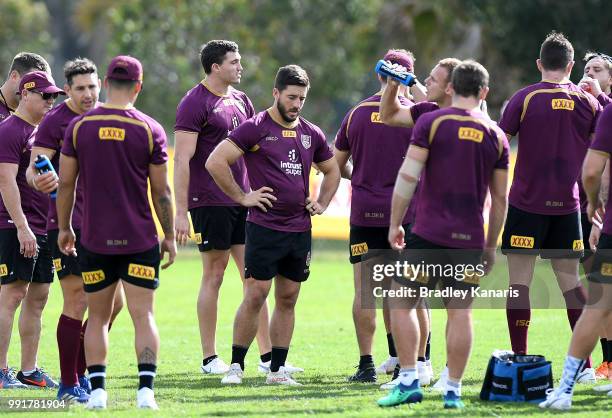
left=0, top=244, right=612, bottom=417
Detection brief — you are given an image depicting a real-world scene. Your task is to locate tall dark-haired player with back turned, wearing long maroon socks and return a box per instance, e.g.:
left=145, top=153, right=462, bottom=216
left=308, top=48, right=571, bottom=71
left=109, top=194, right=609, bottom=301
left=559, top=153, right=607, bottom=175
left=499, top=32, right=601, bottom=382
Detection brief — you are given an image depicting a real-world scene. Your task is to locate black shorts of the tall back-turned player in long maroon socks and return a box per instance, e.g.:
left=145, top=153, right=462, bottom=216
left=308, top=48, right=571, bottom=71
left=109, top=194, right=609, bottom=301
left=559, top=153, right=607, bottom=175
left=502, top=205, right=584, bottom=258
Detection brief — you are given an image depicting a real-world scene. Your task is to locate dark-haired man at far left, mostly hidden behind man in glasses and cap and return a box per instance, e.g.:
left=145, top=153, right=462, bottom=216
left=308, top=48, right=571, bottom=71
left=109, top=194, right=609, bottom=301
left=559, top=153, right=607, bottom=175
left=0, top=52, right=51, bottom=122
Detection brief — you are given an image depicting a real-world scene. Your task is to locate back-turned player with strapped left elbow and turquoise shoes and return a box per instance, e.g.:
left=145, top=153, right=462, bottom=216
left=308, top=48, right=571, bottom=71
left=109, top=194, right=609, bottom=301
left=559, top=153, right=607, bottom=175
left=378, top=61, right=508, bottom=408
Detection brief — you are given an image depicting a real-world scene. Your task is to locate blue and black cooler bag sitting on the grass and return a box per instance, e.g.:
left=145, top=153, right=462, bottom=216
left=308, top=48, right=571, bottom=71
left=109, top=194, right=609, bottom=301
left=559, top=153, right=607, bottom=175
left=480, top=351, right=553, bottom=403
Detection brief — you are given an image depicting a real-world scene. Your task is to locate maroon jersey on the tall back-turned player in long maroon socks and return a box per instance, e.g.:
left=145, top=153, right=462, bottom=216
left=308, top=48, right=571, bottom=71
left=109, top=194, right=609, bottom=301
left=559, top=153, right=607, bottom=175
left=499, top=81, right=601, bottom=215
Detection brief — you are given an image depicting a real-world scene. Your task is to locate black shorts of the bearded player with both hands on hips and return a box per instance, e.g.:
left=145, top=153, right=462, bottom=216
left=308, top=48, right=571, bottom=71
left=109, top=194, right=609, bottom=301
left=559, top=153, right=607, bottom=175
left=244, top=222, right=312, bottom=282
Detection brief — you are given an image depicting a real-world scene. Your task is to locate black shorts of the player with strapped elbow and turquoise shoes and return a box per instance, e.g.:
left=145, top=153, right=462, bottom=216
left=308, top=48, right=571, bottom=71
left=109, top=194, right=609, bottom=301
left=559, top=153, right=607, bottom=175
left=402, top=233, right=482, bottom=290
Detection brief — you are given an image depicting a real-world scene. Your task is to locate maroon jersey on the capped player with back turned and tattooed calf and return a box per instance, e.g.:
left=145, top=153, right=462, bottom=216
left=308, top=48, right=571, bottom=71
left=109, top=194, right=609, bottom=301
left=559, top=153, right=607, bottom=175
left=62, top=104, right=168, bottom=254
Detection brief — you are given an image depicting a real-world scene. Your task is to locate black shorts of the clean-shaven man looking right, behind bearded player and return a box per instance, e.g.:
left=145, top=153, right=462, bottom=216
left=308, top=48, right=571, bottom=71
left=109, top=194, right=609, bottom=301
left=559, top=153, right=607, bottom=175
left=189, top=206, right=248, bottom=252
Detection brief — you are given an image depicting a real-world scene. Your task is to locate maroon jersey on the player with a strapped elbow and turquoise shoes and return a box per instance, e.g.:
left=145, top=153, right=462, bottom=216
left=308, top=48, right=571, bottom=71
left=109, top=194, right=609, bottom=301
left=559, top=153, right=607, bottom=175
left=411, top=107, right=508, bottom=249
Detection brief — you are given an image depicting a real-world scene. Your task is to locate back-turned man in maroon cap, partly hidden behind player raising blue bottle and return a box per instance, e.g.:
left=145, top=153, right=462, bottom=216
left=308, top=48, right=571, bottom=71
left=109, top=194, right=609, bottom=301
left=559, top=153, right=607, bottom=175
left=334, top=50, right=424, bottom=383
